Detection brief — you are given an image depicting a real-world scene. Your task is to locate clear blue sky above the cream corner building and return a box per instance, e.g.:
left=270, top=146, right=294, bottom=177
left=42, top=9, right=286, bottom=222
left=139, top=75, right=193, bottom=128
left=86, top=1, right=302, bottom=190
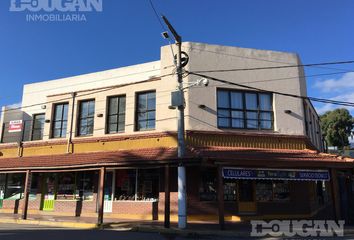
left=0, top=0, right=354, bottom=112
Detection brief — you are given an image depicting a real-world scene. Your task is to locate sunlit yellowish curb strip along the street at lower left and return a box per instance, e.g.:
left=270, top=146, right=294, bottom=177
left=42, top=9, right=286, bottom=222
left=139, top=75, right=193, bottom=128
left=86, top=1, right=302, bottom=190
left=0, top=218, right=97, bottom=229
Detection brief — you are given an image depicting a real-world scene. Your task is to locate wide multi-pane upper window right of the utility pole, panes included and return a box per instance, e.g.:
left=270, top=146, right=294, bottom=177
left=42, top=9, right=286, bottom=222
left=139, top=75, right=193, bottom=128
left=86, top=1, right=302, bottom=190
left=217, top=90, right=273, bottom=130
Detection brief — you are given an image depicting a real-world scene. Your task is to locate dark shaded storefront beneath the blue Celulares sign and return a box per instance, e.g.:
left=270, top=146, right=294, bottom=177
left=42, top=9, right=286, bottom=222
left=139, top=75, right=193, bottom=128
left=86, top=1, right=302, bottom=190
left=189, top=167, right=333, bottom=221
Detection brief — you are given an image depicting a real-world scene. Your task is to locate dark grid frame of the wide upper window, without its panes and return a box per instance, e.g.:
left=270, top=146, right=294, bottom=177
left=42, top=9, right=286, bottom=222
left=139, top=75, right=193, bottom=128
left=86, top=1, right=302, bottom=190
left=216, top=88, right=274, bottom=131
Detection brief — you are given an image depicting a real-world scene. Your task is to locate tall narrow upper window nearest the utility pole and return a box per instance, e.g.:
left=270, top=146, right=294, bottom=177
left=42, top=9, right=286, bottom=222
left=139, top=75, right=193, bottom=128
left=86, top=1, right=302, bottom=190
left=135, top=91, right=156, bottom=131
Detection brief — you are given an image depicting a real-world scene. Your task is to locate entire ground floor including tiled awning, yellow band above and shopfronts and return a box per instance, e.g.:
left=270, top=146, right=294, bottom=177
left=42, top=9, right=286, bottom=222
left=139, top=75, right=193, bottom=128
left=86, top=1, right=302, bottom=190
left=0, top=131, right=354, bottom=226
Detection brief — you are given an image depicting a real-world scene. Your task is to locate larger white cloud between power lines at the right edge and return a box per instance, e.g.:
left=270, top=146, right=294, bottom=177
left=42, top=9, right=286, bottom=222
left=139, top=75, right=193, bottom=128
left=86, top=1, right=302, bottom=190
left=314, top=72, right=354, bottom=92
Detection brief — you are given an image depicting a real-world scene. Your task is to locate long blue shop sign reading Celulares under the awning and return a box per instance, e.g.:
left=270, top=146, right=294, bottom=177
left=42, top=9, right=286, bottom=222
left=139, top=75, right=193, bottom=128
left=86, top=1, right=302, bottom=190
left=223, top=167, right=330, bottom=181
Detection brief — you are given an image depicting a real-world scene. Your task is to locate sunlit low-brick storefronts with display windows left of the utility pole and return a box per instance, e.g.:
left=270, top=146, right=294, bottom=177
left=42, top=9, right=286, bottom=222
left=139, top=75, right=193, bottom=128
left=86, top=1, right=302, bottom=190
left=0, top=168, right=160, bottom=220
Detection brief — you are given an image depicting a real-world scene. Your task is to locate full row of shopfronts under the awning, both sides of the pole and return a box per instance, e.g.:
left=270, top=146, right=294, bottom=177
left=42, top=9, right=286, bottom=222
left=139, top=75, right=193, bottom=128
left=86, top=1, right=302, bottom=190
left=0, top=162, right=353, bottom=226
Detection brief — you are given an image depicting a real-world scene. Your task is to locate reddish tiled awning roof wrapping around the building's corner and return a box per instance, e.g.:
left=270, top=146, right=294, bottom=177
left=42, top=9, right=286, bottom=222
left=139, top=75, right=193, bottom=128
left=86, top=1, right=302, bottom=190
left=0, top=147, right=354, bottom=171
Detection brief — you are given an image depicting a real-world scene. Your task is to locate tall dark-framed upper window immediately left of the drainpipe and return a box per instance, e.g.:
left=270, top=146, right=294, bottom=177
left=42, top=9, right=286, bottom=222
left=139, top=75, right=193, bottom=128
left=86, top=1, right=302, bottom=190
left=52, top=103, right=69, bottom=138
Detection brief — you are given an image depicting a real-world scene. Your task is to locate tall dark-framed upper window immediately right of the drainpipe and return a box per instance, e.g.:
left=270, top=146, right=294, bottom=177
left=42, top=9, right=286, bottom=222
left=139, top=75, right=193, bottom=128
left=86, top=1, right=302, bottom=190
left=77, top=99, right=95, bottom=136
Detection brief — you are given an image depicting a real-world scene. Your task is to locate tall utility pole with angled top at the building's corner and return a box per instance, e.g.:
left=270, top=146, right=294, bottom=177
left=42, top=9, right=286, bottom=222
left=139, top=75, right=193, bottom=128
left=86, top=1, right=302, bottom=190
left=162, top=16, right=187, bottom=229
